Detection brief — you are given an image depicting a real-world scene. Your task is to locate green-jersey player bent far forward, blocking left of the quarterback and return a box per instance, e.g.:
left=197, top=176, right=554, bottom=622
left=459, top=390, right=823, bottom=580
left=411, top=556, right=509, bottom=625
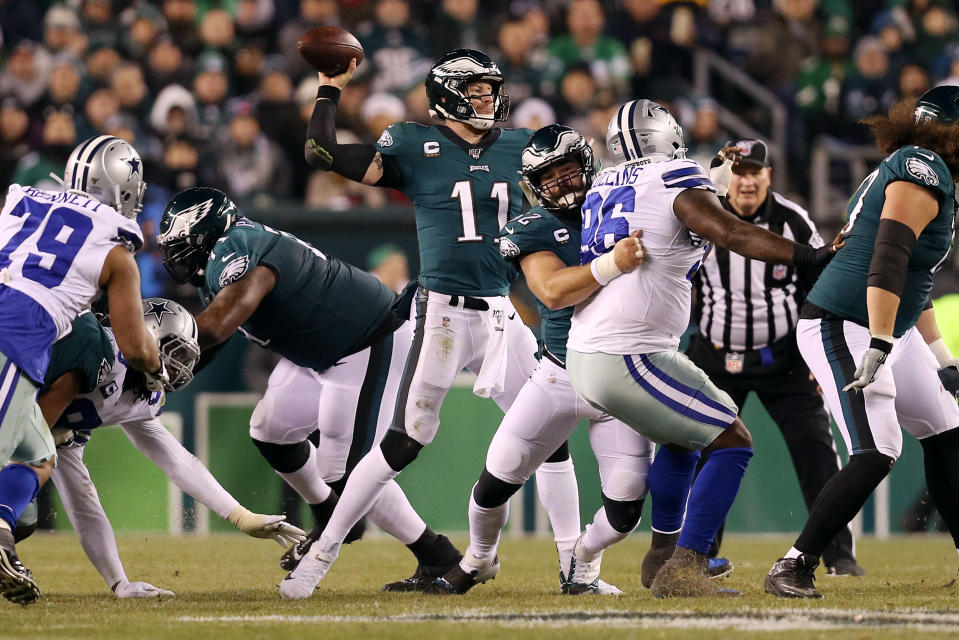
left=158, top=187, right=460, bottom=592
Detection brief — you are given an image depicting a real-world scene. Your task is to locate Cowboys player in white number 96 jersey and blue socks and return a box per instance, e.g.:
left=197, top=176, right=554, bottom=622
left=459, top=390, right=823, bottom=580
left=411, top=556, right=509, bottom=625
left=567, top=100, right=831, bottom=597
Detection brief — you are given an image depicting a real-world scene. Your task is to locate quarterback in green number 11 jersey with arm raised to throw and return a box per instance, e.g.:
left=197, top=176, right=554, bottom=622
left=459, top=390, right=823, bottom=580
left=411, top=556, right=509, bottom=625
left=280, top=49, right=579, bottom=598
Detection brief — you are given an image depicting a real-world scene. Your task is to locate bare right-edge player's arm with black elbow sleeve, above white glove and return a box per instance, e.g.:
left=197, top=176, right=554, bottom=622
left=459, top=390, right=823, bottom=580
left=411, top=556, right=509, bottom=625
left=866, top=181, right=939, bottom=336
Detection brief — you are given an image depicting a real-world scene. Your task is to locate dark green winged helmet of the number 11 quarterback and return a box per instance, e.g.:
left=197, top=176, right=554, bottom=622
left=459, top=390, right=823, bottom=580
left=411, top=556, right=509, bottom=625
left=426, top=49, right=509, bottom=129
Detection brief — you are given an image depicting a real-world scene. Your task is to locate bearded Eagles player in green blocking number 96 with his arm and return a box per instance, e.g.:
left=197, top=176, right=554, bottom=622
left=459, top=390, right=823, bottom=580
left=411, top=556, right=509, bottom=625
left=434, top=124, right=653, bottom=595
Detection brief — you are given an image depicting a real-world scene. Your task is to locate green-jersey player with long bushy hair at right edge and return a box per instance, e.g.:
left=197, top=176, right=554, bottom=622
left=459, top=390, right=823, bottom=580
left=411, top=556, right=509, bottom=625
left=765, top=86, right=959, bottom=598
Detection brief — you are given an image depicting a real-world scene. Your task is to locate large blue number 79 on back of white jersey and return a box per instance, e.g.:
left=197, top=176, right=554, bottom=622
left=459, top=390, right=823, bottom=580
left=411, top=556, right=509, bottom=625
left=0, top=200, right=93, bottom=289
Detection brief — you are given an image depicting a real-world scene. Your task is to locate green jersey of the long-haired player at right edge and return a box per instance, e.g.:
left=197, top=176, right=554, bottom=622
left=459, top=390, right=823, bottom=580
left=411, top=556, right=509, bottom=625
left=806, top=145, right=956, bottom=337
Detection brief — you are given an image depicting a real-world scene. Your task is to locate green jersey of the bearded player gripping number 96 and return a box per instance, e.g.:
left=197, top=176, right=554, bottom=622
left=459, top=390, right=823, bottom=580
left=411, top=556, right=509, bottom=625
left=499, top=206, right=582, bottom=364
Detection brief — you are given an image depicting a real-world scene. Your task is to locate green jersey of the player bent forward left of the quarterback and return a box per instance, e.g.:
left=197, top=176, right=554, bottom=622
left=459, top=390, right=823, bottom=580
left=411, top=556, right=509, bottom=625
left=201, top=218, right=402, bottom=371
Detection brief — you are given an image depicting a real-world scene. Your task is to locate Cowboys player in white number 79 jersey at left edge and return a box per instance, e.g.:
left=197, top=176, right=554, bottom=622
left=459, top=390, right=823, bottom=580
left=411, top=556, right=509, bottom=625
left=0, top=136, right=168, bottom=603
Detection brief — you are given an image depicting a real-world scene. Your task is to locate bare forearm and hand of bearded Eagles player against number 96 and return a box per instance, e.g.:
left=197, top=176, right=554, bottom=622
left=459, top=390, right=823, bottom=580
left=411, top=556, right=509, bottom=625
left=520, top=231, right=646, bottom=311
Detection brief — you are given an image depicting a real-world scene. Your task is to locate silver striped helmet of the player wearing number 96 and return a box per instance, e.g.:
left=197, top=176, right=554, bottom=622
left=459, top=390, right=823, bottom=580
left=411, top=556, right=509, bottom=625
left=606, top=100, right=686, bottom=164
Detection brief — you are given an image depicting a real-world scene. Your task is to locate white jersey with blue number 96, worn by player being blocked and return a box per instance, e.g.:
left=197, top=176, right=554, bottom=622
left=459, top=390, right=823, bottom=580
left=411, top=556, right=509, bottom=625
left=569, top=159, right=715, bottom=355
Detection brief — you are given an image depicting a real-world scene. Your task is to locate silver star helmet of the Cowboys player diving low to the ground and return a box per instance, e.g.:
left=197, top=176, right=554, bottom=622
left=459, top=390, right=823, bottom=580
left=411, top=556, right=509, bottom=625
left=143, top=298, right=200, bottom=389
